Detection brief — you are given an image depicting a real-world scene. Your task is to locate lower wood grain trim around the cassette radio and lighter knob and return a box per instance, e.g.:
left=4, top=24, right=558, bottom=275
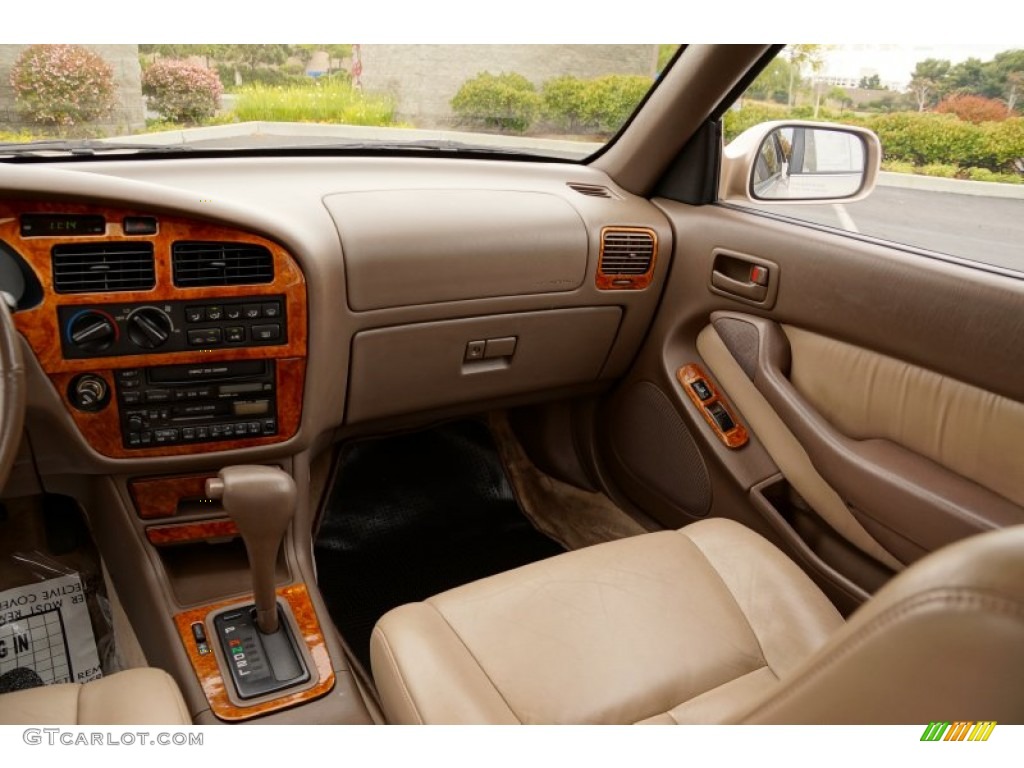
left=50, top=358, right=306, bottom=459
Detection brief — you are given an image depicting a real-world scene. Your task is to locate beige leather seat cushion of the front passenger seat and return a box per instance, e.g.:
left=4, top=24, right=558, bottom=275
left=371, top=519, right=843, bottom=724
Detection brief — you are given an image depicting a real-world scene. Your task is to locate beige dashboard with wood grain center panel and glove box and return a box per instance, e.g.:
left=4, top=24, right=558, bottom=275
left=0, top=158, right=672, bottom=472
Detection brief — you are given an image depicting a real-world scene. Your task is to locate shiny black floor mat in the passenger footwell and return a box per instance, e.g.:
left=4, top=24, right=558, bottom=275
left=314, top=421, right=564, bottom=670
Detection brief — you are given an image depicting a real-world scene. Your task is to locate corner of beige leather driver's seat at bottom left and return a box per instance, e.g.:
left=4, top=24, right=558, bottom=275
left=0, top=669, right=191, bottom=725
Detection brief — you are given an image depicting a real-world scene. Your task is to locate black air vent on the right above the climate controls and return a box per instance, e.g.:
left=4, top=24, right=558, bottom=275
left=171, top=243, right=273, bottom=288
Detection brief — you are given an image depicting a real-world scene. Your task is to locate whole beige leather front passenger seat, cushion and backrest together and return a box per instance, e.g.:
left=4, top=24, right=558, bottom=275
left=371, top=519, right=1024, bottom=724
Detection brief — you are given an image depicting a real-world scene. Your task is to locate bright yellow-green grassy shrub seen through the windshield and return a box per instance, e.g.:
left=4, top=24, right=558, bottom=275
left=234, top=78, right=394, bottom=126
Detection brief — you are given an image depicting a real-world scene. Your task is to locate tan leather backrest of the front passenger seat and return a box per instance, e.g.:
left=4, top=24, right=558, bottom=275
left=741, top=525, right=1024, bottom=726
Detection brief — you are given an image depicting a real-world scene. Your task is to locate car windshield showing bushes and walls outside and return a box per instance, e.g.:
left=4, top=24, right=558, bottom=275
left=0, top=44, right=678, bottom=160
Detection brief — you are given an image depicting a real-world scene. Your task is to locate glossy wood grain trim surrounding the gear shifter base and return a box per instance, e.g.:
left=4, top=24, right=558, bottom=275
left=174, top=584, right=335, bottom=722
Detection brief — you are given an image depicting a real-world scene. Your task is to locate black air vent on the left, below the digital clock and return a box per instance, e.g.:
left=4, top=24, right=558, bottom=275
left=50, top=243, right=156, bottom=293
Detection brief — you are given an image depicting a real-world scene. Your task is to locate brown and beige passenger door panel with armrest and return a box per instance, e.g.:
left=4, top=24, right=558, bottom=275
left=608, top=201, right=1024, bottom=589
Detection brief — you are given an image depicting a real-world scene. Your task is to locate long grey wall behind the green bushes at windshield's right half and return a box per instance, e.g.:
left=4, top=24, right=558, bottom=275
left=360, top=45, right=657, bottom=128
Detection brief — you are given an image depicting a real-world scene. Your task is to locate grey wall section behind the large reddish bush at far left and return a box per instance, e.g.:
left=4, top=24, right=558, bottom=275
left=0, top=45, right=145, bottom=135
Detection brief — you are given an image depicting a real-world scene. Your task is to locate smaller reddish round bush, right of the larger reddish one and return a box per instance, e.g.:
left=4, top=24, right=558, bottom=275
left=142, top=59, right=223, bottom=125
